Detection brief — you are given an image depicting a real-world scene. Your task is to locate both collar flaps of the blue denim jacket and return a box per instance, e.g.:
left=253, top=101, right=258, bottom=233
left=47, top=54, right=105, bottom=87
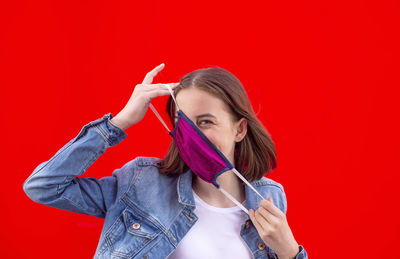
left=177, top=169, right=262, bottom=220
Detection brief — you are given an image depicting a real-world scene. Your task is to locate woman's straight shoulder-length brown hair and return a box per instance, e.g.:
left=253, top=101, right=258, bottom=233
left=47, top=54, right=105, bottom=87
left=157, top=66, right=276, bottom=181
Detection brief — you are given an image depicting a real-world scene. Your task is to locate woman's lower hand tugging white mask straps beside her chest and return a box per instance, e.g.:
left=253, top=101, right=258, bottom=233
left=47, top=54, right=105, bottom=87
left=249, top=197, right=299, bottom=259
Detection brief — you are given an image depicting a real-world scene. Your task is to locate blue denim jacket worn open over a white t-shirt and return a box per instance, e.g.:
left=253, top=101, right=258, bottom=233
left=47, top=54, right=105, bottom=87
left=23, top=113, right=308, bottom=259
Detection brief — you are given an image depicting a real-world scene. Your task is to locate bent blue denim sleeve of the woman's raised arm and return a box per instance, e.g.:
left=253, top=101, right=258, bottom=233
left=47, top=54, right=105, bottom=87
left=23, top=113, right=133, bottom=218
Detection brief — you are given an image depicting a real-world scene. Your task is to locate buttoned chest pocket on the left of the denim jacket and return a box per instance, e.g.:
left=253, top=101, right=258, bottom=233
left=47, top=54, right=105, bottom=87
left=105, top=207, right=161, bottom=258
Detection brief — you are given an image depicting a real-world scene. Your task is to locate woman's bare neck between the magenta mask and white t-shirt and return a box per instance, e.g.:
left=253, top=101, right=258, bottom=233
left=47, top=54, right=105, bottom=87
left=192, top=170, right=245, bottom=208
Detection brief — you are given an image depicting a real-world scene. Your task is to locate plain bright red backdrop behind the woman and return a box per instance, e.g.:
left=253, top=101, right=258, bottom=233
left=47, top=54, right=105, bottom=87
left=0, top=0, right=400, bottom=259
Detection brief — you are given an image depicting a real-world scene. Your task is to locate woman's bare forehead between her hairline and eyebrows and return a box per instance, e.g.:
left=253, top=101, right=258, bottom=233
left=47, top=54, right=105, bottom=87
left=176, top=87, right=229, bottom=117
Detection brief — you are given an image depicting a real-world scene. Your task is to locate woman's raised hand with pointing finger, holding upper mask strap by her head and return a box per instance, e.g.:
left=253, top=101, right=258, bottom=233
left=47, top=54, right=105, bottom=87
left=111, top=63, right=179, bottom=130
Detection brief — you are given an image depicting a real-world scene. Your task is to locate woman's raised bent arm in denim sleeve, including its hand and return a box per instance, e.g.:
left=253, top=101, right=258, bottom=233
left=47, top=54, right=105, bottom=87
left=23, top=63, right=178, bottom=218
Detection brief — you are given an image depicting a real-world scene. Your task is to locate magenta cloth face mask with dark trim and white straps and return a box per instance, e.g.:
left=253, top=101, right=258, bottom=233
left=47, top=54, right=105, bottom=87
left=150, top=85, right=264, bottom=214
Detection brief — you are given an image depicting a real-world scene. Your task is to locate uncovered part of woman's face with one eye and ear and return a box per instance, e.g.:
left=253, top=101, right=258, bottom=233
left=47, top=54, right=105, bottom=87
left=175, top=87, right=247, bottom=164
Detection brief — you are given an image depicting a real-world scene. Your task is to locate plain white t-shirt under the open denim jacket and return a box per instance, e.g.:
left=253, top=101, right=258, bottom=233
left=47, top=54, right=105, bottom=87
left=168, top=191, right=253, bottom=259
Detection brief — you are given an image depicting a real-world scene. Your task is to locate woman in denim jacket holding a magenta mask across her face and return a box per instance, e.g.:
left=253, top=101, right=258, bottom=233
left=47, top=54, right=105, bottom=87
left=23, top=64, right=307, bottom=259
